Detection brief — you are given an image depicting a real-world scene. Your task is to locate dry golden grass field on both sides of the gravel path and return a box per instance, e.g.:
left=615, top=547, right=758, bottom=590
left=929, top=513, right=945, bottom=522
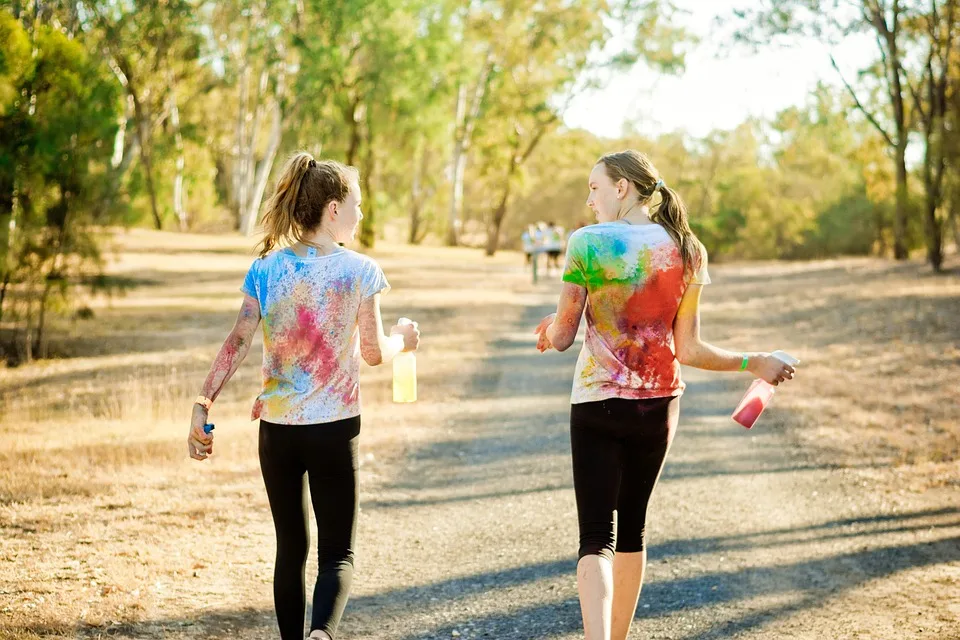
left=0, top=231, right=960, bottom=640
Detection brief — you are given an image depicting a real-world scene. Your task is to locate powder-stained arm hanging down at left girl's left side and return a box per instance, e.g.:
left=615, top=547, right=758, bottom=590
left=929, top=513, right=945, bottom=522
left=187, top=295, right=260, bottom=460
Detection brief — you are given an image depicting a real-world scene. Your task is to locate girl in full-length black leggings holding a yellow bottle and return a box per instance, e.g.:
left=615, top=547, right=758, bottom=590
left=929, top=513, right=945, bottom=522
left=187, top=153, right=420, bottom=640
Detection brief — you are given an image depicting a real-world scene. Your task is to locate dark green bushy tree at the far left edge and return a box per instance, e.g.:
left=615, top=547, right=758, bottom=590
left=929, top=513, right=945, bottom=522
left=0, top=13, right=120, bottom=358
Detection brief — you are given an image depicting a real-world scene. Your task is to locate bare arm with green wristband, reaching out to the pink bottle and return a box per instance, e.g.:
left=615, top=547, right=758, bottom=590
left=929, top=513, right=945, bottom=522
left=673, top=284, right=794, bottom=385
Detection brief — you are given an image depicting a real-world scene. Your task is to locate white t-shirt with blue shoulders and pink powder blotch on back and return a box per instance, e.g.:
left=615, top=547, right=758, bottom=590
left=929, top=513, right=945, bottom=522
left=241, top=249, right=390, bottom=424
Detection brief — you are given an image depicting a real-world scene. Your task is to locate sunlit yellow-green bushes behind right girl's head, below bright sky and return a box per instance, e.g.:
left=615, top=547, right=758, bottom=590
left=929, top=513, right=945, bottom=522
left=508, top=87, right=896, bottom=259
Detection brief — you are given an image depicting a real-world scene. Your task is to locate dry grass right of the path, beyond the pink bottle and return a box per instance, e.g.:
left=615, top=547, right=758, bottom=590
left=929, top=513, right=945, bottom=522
left=705, top=258, right=960, bottom=488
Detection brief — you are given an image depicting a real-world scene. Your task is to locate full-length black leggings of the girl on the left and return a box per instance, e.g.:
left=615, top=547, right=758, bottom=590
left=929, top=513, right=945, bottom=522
left=260, top=416, right=360, bottom=640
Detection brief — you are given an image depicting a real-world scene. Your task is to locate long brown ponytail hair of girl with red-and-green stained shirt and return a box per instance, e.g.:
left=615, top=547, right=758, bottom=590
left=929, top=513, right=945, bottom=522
left=597, top=149, right=703, bottom=277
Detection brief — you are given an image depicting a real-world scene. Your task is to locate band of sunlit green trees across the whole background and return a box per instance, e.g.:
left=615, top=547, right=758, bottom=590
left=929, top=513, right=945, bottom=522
left=0, top=0, right=944, bottom=355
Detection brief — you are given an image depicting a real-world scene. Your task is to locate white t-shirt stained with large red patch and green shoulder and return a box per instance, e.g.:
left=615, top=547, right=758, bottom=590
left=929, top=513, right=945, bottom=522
left=563, top=222, right=710, bottom=404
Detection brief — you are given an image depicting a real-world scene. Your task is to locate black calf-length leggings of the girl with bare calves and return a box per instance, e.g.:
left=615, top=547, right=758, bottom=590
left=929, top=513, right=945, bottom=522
left=570, top=397, right=680, bottom=560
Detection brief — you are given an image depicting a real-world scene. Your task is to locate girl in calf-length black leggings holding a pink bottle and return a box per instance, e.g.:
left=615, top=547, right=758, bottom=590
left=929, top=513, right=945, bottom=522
left=536, top=150, right=794, bottom=640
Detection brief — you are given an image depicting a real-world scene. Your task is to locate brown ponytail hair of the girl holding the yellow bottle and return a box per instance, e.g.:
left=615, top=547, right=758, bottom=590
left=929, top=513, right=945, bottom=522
left=257, top=151, right=360, bottom=258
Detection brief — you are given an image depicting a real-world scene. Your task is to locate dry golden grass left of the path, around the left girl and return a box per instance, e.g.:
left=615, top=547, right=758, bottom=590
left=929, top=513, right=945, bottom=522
left=0, top=232, right=536, bottom=640
